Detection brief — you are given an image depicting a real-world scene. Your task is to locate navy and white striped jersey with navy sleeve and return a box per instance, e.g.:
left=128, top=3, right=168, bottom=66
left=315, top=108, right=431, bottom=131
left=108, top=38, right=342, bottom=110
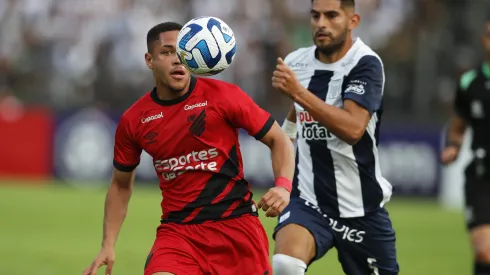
left=285, top=38, right=392, bottom=218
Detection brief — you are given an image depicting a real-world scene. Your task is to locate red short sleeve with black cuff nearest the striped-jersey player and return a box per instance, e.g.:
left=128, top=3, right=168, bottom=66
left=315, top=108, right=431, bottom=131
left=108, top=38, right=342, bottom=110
left=225, top=86, right=275, bottom=140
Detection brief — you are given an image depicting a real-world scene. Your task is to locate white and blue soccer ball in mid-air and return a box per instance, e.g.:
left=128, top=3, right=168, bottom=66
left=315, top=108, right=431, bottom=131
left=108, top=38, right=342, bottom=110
left=177, top=16, right=236, bottom=76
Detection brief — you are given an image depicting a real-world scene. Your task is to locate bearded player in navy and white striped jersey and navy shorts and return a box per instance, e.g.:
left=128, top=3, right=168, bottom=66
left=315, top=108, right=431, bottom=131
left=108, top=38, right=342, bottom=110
left=272, top=0, right=399, bottom=275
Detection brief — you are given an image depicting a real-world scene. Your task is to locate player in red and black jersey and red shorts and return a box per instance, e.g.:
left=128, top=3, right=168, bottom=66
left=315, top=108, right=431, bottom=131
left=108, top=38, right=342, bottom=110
left=83, top=22, right=294, bottom=275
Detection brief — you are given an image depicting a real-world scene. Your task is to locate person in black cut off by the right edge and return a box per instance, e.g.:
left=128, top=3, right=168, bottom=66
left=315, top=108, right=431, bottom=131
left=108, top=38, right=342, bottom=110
left=441, top=19, right=490, bottom=275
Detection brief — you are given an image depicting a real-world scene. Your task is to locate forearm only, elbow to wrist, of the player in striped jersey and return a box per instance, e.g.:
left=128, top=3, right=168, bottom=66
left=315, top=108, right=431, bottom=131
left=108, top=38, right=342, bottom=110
left=294, top=88, right=365, bottom=144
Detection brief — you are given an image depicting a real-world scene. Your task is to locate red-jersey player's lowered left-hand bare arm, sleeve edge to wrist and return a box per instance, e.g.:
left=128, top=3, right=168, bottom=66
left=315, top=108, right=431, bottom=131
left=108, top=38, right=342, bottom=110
left=102, top=169, right=135, bottom=247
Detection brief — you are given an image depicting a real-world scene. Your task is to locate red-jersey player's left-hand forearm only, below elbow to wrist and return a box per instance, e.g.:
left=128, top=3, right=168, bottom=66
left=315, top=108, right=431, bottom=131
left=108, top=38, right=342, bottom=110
left=102, top=180, right=132, bottom=247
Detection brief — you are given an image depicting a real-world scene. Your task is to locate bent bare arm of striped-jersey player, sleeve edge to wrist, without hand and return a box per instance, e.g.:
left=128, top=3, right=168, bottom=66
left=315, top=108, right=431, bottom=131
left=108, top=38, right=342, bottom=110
left=294, top=88, right=371, bottom=145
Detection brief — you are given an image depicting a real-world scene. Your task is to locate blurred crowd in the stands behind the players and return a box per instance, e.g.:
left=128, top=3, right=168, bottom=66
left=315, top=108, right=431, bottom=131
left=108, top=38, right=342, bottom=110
left=0, top=0, right=490, bottom=123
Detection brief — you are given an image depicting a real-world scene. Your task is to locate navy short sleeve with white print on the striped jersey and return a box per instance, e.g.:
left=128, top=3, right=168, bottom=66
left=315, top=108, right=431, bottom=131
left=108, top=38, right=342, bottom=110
left=343, top=55, right=384, bottom=114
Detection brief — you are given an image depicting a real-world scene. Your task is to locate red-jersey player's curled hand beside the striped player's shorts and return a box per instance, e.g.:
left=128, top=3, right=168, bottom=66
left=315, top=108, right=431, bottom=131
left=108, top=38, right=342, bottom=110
left=257, top=186, right=290, bottom=217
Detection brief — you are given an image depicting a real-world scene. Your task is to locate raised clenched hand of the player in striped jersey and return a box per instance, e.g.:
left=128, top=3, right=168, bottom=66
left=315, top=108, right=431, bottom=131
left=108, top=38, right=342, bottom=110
left=272, top=57, right=303, bottom=99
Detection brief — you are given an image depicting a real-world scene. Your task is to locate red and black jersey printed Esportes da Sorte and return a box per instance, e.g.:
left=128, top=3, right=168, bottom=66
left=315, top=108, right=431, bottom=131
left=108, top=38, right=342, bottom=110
left=114, top=77, right=274, bottom=223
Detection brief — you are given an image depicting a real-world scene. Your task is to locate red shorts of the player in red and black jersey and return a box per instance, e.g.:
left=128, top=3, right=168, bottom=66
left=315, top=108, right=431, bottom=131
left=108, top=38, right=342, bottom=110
left=145, top=215, right=272, bottom=275
